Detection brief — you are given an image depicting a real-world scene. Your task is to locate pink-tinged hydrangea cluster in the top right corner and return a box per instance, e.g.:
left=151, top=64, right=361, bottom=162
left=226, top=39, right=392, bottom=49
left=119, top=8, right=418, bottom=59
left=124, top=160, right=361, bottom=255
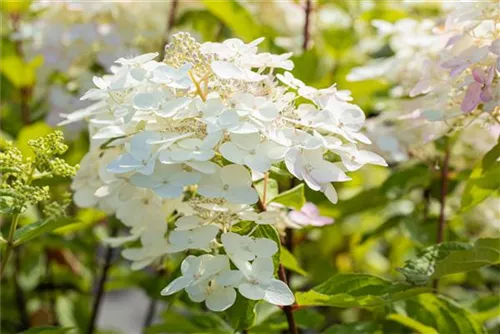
left=410, top=1, right=500, bottom=115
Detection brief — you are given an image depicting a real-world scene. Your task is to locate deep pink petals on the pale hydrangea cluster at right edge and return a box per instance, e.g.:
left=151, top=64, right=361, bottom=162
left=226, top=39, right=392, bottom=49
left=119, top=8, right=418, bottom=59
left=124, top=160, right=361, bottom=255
left=461, top=67, right=495, bottom=112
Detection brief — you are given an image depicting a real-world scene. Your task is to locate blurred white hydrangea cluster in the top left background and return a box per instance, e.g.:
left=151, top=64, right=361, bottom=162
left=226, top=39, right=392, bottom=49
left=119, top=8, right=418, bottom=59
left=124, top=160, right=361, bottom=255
left=18, top=0, right=182, bottom=129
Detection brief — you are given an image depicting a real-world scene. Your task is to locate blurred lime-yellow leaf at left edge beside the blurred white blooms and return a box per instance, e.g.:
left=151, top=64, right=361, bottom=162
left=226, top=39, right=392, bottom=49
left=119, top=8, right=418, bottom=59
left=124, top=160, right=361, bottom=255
left=0, top=55, right=43, bottom=88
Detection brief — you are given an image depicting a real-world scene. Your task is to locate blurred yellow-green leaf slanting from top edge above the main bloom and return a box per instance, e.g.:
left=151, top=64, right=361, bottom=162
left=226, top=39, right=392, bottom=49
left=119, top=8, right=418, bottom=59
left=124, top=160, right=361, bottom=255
left=202, top=0, right=261, bottom=42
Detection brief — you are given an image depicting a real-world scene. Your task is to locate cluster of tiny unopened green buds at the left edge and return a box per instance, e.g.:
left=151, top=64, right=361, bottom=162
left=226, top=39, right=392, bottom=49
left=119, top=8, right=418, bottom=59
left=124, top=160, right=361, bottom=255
left=0, top=131, right=78, bottom=214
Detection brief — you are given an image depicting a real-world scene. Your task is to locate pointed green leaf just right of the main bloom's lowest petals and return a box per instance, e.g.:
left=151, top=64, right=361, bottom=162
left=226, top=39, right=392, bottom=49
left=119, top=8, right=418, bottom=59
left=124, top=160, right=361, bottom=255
left=295, top=274, right=430, bottom=307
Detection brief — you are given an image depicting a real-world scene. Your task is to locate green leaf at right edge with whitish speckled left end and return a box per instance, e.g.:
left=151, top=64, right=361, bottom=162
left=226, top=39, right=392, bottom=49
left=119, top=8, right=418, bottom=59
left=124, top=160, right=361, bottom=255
left=399, top=239, right=500, bottom=284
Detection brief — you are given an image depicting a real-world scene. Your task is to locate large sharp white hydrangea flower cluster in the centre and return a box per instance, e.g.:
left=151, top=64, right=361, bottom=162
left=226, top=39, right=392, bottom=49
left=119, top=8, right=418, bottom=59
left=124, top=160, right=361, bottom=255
left=66, top=33, right=385, bottom=311
